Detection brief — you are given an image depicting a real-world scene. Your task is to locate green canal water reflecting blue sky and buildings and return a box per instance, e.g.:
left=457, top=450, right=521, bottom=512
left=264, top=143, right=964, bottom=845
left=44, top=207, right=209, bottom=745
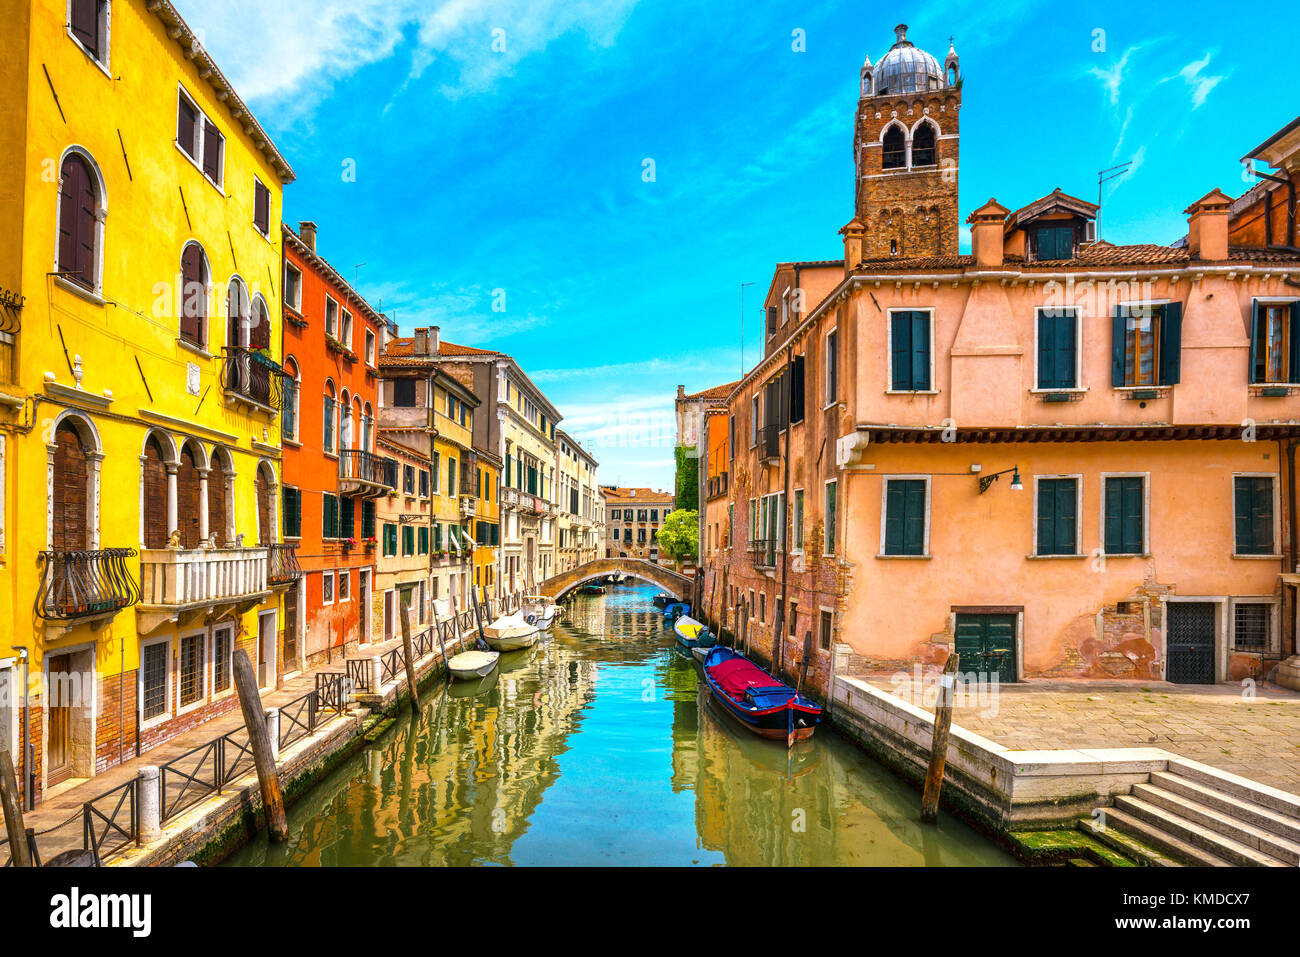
left=229, top=585, right=1014, bottom=866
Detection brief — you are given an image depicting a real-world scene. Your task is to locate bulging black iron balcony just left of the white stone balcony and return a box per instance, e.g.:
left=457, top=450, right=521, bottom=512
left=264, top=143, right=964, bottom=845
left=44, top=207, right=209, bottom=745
left=35, top=549, right=140, bottom=637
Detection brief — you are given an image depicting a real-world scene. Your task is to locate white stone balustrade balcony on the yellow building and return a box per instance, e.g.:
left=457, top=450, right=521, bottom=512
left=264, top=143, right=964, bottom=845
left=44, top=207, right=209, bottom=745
left=135, top=546, right=274, bottom=635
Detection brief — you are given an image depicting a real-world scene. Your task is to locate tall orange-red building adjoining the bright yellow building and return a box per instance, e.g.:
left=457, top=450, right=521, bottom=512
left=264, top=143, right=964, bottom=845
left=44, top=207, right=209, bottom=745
left=283, top=222, right=397, bottom=668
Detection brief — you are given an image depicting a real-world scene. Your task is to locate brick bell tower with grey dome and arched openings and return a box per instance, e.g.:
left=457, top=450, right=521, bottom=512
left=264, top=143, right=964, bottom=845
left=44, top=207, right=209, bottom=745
left=853, top=23, right=962, bottom=259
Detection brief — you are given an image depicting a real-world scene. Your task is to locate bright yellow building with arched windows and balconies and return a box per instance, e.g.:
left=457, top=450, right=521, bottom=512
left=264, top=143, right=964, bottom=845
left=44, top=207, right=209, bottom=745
left=0, top=0, right=296, bottom=796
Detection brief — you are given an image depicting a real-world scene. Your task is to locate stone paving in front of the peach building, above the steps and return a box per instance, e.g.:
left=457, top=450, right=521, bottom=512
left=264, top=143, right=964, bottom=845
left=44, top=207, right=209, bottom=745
left=861, top=675, right=1300, bottom=794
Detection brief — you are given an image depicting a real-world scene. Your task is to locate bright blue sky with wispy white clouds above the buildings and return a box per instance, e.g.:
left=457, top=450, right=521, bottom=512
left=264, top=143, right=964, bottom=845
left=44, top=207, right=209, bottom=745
left=177, top=0, right=1296, bottom=488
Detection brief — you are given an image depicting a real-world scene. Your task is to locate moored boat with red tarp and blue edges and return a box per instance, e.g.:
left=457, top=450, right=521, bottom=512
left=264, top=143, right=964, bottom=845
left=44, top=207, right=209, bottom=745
left=703, top=645, right=822, bottom=746
